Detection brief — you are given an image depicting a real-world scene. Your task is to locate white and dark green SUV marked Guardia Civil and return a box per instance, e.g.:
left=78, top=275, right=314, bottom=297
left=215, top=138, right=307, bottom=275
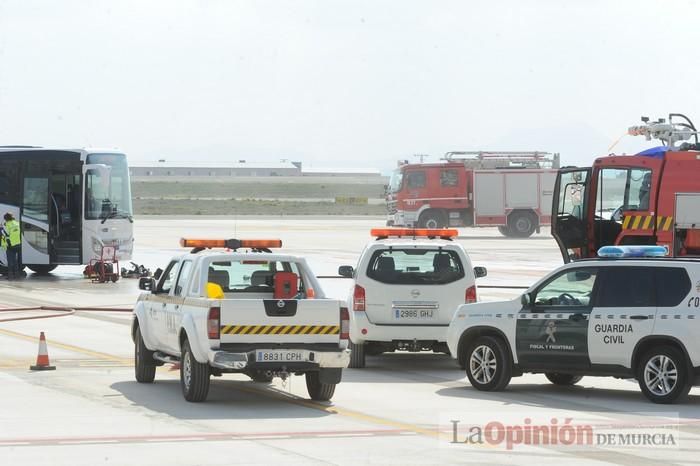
left=447, top=247, right=700, bottom=403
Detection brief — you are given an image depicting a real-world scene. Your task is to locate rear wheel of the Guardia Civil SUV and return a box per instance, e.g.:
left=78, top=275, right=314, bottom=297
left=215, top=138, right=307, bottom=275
left=637, top=346, right=691, bottom=404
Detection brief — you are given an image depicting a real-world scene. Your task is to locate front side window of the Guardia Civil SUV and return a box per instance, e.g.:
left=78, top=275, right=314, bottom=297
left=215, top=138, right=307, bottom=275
left=533, top=267, right=598, bottom=311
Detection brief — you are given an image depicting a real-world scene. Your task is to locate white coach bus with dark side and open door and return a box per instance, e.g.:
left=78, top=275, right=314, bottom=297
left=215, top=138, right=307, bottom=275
left=0, top=146, right=134, bottom=274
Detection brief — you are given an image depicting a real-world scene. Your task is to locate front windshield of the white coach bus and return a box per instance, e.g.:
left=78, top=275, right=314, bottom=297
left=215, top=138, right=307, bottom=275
left=85, top=154, right=132, bottom=220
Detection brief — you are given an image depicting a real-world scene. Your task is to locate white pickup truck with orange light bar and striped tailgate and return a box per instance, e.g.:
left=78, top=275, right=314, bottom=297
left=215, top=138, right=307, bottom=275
left=131, top=239, right=350, bottom=401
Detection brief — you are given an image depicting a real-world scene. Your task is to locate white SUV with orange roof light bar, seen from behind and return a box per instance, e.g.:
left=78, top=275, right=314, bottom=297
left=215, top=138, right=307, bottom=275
left=338, top=228, right=486, bottom=368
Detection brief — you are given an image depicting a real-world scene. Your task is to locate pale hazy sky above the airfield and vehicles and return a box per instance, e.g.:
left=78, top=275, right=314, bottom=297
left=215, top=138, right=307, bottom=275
left=0, top=0, right=700, bottom=170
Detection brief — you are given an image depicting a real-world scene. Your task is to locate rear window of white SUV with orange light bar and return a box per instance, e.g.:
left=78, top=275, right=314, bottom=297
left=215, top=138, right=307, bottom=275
left=367, top=248, right=464, bottom=285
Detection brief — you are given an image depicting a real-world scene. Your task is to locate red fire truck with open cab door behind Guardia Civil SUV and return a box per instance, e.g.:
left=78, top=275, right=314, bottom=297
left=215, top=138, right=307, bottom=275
left=552, top=113, right=700, bottom=262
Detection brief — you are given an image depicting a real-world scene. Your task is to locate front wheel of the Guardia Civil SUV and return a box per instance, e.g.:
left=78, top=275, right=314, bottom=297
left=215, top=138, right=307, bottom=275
left=464, top=336, right=512, bottom=391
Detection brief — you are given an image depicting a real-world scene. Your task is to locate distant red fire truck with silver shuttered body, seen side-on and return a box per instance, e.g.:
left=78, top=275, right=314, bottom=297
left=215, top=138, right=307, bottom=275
left=386, top=152, right=559, bottom=237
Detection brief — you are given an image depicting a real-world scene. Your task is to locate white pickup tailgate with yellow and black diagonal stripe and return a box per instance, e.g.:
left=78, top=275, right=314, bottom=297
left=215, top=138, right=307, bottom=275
left=220, top=299, right=340, bottom=343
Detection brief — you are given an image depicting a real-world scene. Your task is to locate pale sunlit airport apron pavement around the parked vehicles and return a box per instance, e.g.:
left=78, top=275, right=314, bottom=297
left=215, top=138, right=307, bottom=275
left=0, top=217, right=700, bottom=465
